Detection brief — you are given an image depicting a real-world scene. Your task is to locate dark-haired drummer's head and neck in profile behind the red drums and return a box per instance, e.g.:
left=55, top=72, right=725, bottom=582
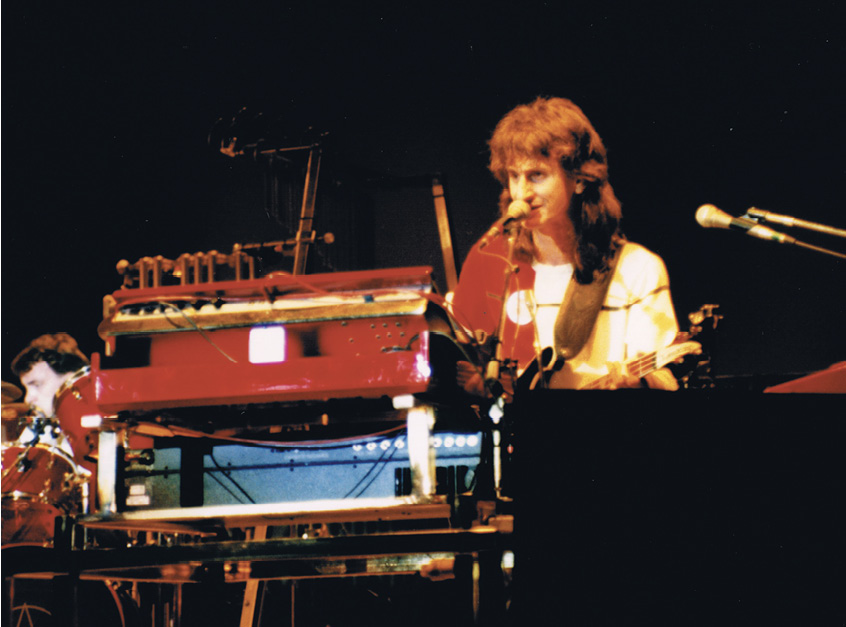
left=12, top=333, right=88, bottom=457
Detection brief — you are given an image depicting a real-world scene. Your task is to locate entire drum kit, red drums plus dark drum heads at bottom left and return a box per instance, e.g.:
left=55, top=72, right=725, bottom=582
left=2, top=376, right=140, bottom=627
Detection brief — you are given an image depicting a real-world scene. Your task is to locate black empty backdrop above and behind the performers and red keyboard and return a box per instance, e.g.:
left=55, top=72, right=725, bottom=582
left=2, top=0, right=846, bottom=388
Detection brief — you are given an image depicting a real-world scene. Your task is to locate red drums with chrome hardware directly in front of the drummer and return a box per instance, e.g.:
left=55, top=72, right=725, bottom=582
left=2, top=377, right=93, bottom=547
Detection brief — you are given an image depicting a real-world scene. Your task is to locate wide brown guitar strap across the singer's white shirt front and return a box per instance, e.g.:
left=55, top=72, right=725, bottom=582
left=553, top=247, right=622, bottom=370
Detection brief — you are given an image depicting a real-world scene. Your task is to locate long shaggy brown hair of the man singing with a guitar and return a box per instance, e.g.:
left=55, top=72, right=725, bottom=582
left=488, top=97, right=624, bottom=284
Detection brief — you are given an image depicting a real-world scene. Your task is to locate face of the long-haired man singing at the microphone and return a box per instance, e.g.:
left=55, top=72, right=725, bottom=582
left=507, top=157, right=576, bottom=235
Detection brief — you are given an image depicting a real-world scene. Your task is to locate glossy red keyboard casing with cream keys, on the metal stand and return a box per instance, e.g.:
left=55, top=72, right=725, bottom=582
left=91, top=267, right=450, bottom=414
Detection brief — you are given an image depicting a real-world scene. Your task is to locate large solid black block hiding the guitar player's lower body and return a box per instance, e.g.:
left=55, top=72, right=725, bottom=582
left=510, top=390, right=846, bottom=627
